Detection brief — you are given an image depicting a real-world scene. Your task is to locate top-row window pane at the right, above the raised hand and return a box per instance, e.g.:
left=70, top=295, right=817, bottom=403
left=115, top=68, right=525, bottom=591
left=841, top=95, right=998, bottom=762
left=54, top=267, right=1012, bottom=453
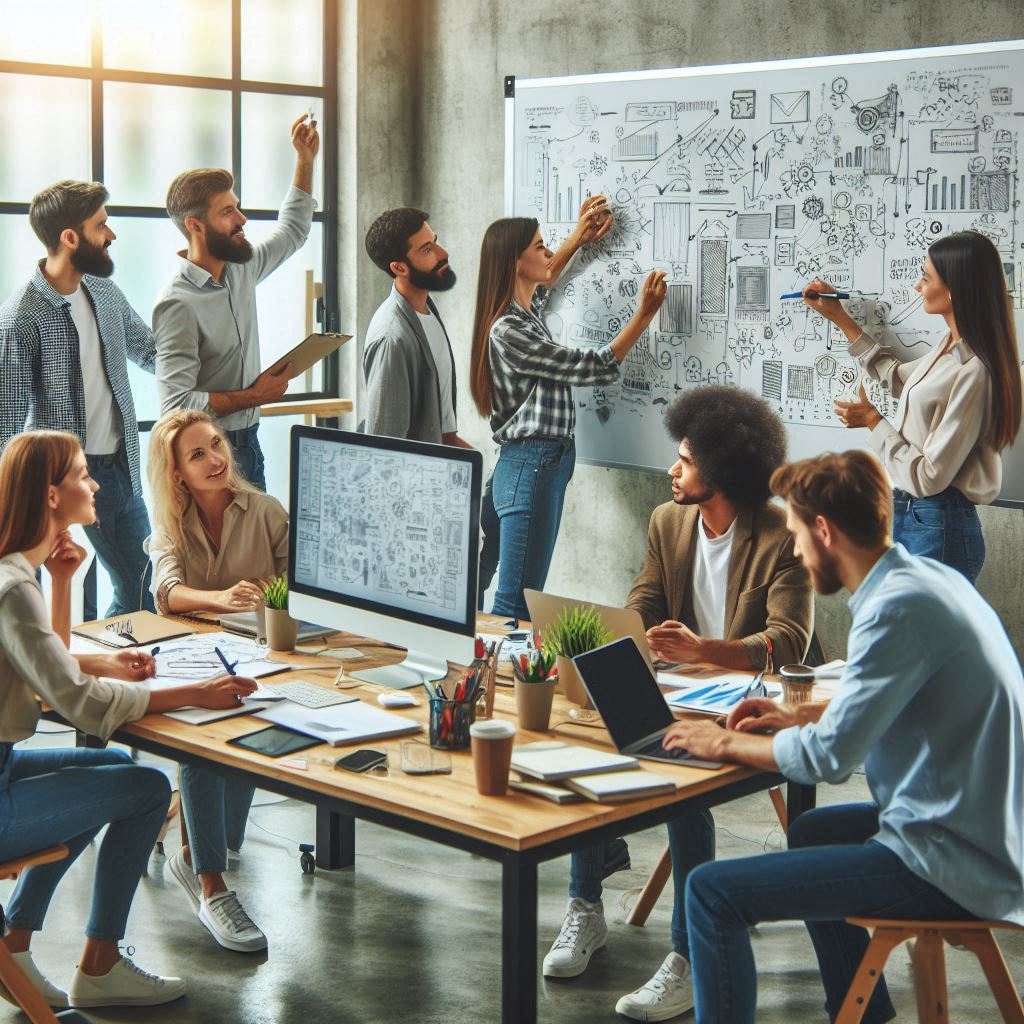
left=242, top=0, right=324, bottom=85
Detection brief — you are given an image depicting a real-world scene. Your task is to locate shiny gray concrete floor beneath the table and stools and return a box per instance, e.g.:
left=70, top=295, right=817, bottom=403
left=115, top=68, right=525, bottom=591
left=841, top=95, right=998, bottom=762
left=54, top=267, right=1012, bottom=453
left=0, top=735, right=1024, bottom=1024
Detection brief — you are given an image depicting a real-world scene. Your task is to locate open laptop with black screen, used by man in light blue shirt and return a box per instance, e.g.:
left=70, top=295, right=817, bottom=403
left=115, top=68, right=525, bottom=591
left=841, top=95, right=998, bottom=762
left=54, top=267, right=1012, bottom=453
left=572, top=637, right=722, bottom=768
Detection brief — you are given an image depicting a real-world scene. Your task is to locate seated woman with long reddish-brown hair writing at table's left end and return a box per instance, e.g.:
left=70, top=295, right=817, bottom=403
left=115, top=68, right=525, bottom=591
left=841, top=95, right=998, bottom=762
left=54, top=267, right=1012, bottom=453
left=0, top=430, right=256, bottom=1008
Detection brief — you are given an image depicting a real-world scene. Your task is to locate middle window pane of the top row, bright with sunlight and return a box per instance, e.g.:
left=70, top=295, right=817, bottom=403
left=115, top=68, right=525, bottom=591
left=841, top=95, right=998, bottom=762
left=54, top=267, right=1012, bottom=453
left=102, top=0, right=231, bottom=78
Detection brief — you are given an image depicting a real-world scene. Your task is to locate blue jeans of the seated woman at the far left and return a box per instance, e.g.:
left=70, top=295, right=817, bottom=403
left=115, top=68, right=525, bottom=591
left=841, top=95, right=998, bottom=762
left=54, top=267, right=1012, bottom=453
left=0, top=743, right=171, bottom=942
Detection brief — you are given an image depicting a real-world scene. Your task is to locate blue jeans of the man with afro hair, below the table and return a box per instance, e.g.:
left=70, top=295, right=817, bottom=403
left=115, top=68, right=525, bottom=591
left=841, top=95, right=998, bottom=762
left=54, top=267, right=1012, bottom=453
left=569, top=810, right=715, bottom=959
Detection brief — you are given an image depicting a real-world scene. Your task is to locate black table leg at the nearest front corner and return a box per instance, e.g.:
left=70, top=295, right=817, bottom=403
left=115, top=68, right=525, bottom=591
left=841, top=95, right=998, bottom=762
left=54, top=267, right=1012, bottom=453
left=502, top=852, right=537, bottom=1024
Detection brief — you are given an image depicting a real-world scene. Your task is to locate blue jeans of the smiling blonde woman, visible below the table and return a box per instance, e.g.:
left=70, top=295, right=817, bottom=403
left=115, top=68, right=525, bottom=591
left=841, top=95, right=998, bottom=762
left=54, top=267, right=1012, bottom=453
left=178, top=765, right=256, bottom=874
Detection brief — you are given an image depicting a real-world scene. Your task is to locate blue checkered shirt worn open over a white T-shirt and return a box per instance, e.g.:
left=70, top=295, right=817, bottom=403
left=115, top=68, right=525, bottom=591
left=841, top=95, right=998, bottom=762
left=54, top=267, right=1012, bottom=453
left=0, top=265, right=157, bottom=495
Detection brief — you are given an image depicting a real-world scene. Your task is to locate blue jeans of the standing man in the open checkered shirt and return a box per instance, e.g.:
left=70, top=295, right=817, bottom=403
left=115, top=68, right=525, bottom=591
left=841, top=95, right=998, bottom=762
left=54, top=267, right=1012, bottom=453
left=85, top=446, right=156, bottom=618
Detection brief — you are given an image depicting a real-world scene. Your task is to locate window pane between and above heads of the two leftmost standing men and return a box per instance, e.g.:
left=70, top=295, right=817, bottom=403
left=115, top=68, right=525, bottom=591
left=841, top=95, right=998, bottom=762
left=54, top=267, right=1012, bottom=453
left=103, top=82, right=231, bottom=208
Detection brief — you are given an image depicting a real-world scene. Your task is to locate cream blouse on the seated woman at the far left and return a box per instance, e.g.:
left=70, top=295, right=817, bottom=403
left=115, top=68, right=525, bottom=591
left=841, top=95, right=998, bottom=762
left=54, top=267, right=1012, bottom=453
left=0, top=554, right=150, bottom=742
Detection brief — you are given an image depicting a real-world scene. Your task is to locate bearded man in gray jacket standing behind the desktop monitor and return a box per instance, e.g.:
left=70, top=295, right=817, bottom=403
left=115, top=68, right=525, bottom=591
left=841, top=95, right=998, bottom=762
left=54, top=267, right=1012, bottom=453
left=362, top=207, right=499, bottom=607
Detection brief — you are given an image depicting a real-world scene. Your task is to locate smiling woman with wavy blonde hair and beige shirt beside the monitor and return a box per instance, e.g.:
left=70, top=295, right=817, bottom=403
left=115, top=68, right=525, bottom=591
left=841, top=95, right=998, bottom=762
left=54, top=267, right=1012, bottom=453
left=148, top=410, right=288, bottom=952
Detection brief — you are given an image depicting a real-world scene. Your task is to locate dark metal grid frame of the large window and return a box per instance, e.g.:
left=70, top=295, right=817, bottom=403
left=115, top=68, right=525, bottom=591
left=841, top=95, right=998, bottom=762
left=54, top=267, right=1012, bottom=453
left=0, top=0, right=341, bottom=432
